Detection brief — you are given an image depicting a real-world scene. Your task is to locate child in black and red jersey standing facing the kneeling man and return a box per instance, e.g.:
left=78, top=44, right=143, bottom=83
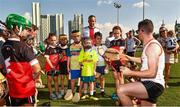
left=110, top=26, right=125, bottom=98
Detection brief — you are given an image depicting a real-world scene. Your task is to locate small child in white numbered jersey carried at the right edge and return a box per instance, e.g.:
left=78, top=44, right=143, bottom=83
left=166, top=30, right=178, bottom=63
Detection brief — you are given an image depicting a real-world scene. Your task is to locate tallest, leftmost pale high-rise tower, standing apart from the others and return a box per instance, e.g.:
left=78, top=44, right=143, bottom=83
left=32, top=2, right=41, bottom=43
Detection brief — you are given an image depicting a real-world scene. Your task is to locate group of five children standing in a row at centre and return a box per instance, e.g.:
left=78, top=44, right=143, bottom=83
left=44, top=30, right=107, bottom=100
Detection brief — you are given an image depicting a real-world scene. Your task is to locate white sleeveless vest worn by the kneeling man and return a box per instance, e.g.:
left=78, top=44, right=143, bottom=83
left=141, top=40, right=165, bottom=86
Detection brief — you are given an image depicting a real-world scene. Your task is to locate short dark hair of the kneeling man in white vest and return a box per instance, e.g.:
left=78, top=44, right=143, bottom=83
left=138, top=19, right=154, bottom=33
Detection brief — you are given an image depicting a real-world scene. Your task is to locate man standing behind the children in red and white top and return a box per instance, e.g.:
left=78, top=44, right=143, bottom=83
left=83, top=15, right=100, bottom=45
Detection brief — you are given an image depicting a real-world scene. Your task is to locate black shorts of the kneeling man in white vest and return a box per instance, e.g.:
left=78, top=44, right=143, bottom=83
left=141, top=81, right=164, bottom=103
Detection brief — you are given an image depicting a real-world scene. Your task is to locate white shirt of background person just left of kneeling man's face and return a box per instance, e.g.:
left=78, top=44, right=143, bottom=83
left=126, top=37, right=136, bottom=52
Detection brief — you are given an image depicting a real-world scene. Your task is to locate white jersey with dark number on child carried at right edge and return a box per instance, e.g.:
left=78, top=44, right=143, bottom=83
left=166, top=37, right=177, bottom=49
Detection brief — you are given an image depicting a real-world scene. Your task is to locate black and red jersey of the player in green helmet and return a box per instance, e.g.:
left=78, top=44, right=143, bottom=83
left=2, top=38, right=38, bottom=98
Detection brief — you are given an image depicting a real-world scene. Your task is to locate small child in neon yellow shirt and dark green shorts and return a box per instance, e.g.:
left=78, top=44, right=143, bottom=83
left=78, top=37, right=98, bottom=100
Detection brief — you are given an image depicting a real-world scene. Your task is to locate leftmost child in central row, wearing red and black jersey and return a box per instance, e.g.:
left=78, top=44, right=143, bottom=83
left=45, top=33, right=62, bottom=100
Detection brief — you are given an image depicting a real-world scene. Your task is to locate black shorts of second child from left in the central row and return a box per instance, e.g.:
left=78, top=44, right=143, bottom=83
left=59, top=61, right=68, bottom=75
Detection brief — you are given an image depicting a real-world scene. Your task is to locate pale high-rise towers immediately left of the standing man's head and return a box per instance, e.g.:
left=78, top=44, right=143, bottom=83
left=68, top=14, right=83, bottom=40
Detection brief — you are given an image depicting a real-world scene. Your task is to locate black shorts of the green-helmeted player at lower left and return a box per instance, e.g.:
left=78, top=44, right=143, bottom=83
left=10, top=95, right=35, bottom=106
